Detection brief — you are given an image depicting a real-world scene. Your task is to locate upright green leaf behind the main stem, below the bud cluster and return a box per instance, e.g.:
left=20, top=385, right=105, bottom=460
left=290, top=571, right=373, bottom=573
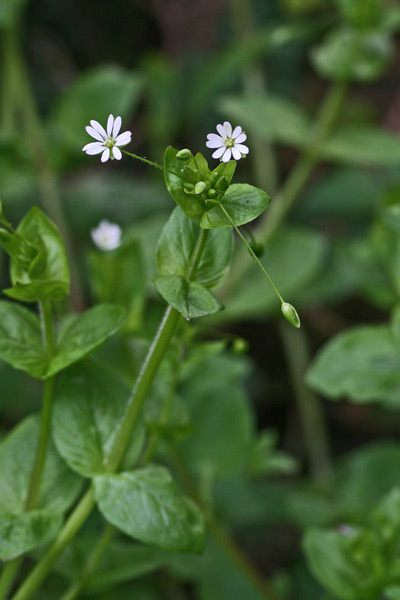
left=156, top=207, right=233, bottom=287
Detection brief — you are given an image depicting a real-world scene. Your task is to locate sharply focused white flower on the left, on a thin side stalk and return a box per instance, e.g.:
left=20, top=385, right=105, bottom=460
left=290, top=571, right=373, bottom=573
left=82, top=115, right=132, bottom=162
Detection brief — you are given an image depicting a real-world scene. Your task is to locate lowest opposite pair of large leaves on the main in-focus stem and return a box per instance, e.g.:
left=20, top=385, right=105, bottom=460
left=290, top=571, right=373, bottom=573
left=53, top=362, right=204, bottom=552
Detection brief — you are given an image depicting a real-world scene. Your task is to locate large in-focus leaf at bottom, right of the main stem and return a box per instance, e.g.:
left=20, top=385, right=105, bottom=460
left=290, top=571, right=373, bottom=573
left=94, top=465, right=204, bottom=553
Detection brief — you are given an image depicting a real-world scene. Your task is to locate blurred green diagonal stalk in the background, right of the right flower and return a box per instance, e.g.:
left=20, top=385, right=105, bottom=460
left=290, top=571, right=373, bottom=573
left=220, top=82, right=347, bottom=301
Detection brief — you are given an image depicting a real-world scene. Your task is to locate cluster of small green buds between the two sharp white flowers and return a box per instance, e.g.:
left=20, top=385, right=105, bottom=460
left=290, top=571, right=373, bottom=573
left=176, top=148, right=229, bottom=202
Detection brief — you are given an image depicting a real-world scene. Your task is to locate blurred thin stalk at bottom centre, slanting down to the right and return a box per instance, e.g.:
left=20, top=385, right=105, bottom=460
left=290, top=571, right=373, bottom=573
left=169, top=444, right=278, bottom=600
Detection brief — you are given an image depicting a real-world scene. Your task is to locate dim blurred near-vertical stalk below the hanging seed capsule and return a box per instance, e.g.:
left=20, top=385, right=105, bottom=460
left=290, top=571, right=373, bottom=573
left=280, top=323, right=332, bottom=481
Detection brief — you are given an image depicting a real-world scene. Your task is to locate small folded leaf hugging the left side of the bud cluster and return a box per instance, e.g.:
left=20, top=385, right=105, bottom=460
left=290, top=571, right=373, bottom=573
left=164, top=147, right=205, bottom=220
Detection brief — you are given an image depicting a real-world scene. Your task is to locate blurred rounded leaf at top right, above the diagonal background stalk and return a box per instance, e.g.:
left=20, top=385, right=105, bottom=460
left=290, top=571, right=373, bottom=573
left=311, top=27, right=393, bottom=82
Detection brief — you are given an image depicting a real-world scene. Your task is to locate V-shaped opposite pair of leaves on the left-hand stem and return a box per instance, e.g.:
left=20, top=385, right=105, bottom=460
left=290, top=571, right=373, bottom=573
left=0, top=301, right=126, bottom=379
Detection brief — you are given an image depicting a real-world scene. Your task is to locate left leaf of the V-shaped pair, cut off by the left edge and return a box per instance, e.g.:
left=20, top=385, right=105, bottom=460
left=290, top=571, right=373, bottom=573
left=0, top=301, right=47, bottom=378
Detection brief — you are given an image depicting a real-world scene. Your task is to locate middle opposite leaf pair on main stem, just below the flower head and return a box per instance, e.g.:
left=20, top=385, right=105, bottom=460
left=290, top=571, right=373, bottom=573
left=155, top=207, right=233, bottom=319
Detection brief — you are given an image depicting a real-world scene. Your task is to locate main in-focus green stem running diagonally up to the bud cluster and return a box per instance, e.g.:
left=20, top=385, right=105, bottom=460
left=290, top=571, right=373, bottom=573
left=11, top=229, right=208, bottom=600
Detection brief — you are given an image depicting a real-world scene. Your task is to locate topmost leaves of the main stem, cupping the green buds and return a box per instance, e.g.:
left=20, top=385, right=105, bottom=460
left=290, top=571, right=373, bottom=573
left=164, top=147, right=269, bottom=229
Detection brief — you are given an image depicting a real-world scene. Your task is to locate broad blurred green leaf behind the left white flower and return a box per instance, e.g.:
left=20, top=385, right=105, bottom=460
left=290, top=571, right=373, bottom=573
left=50, top=65, right=143, bottom=157
